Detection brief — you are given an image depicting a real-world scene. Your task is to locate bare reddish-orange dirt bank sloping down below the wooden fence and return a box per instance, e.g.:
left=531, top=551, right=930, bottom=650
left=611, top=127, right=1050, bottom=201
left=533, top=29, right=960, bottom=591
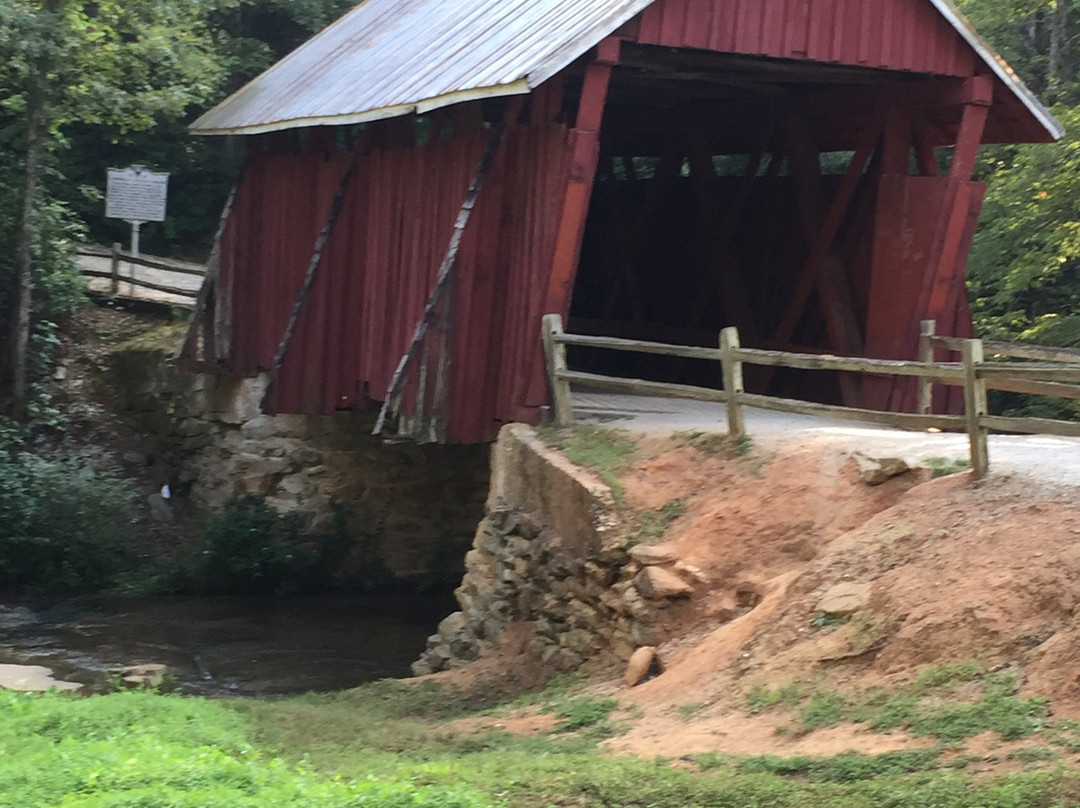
left=610, top=440, right=1080, bottom=754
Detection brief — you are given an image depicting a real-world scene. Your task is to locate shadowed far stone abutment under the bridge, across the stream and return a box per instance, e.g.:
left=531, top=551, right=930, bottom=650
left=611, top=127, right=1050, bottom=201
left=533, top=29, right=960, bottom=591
left=112, top=352, right=489, bottom=582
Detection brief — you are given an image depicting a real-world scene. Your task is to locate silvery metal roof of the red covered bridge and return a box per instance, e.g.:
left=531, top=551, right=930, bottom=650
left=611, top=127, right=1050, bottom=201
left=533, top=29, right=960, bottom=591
left=191, top=0, right=1064, bottom=139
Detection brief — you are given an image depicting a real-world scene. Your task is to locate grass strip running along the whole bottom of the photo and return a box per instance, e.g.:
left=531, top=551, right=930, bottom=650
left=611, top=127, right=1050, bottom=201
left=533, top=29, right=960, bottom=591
left=0, top=683, right=1080, bottom=808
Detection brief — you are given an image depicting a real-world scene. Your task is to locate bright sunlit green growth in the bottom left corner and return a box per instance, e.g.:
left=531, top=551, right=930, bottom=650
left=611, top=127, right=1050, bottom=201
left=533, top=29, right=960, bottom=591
left=0, top=692, right=489, bottom=808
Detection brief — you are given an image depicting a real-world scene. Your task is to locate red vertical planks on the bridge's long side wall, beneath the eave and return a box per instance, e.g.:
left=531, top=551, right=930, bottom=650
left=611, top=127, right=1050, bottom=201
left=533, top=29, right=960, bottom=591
left=221, top=124, right=569, bottom=443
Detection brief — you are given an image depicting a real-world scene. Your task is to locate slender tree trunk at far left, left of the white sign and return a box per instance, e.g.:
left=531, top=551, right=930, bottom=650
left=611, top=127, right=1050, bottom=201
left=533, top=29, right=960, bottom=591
left=11, top=93, right=44, bottom=419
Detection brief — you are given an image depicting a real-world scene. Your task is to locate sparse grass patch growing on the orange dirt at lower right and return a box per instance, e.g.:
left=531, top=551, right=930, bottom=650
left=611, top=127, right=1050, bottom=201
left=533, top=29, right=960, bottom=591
left=747, top=664, right=1048, bottom=741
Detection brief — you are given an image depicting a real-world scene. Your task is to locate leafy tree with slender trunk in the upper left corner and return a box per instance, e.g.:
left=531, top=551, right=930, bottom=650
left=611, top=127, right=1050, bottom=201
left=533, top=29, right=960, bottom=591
left=0, top=0, right=226, bottom=417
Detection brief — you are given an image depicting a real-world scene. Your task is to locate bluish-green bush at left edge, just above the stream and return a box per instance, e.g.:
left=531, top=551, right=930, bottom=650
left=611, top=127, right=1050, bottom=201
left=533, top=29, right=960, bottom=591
left=0, top=452, right=133, bottom=592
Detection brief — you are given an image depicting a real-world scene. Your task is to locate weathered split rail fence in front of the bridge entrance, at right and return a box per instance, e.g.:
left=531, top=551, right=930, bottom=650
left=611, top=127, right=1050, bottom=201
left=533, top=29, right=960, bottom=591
left=542, top=314, right=1080, bottom=477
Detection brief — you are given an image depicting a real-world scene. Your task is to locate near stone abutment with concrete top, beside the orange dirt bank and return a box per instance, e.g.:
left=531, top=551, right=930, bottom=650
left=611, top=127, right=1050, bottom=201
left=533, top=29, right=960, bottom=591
left=413, top=425, right=700, bottom=675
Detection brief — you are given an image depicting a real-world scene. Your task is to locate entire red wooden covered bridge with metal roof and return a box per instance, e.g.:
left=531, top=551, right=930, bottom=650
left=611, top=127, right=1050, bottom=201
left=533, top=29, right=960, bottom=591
left=185, top=0, right=1062, bottom=443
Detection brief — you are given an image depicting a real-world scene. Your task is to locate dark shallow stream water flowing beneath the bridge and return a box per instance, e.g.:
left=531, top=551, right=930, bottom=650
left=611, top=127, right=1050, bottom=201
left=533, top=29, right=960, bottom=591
left=0, top=593, right=455, bottom=696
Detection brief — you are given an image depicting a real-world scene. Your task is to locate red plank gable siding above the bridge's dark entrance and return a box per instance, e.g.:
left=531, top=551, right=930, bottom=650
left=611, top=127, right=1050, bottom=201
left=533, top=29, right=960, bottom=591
left=636, top=0, right=975, bottom=76
